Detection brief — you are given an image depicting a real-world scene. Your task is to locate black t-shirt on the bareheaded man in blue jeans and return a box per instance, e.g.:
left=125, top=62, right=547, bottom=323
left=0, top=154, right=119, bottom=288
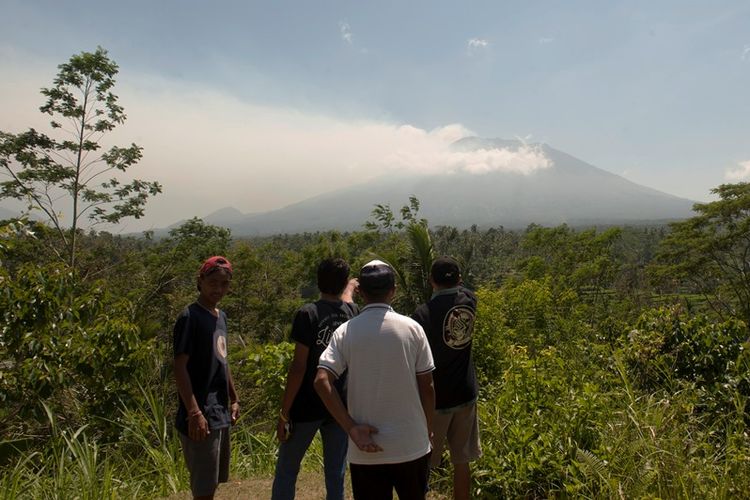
left=289, top=299, right=359, bottom=422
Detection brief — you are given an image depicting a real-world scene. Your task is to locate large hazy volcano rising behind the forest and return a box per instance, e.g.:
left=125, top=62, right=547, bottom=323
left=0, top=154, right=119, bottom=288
left=198, top=137, right=694, bottom=236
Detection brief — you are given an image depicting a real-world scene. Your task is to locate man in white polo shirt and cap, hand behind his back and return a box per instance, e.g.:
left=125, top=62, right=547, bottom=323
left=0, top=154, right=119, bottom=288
left=315, top=260, right=435, bottom=500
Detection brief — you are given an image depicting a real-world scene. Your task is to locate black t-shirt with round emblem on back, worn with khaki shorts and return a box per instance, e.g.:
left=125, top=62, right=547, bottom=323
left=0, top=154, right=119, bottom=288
left=412, top=287, right=477, bottom=409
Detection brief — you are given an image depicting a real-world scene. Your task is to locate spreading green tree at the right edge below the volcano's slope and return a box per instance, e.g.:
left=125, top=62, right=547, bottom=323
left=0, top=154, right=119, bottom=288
left=652, top=182, right=750, bottom=327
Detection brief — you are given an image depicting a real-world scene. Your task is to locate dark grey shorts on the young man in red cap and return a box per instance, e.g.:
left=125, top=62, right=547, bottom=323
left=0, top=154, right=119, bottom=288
left=179, top=427, right=230, bottom=497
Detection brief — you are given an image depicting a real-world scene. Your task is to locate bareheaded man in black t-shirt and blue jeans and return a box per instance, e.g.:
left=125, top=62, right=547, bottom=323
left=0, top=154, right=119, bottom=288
left=271, top=259, right=359, bottom=500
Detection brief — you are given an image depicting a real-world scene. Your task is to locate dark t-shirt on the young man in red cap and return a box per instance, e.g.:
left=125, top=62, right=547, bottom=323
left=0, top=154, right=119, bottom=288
left=174, top=303, right=231, bottom=434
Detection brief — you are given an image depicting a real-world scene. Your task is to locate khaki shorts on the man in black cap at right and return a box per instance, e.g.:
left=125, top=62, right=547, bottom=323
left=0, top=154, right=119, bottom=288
left=430, top=403, right=482, bottom=467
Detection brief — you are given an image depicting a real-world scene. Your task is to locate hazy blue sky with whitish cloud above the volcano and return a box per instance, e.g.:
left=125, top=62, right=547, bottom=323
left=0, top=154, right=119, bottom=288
left=0, top=0, right=750, bottom=230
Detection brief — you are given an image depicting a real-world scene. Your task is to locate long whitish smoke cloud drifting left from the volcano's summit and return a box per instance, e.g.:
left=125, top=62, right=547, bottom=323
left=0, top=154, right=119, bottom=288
left=0, top=48, right=549, bottom=231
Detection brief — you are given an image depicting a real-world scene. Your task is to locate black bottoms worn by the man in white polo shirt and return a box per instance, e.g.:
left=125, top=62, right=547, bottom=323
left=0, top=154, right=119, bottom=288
left=349, top=453, right=430, bottom=500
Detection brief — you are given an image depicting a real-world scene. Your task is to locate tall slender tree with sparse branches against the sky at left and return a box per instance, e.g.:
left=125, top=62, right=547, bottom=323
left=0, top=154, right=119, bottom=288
left=0, top=47, right=161, bottom=267
